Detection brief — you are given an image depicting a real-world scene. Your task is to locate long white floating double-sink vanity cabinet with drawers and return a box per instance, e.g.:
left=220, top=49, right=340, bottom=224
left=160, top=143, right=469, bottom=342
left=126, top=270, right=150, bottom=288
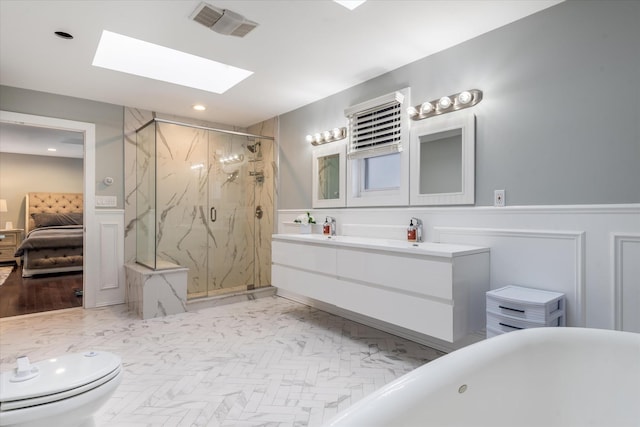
left=272, top=235, right=489, bottom=342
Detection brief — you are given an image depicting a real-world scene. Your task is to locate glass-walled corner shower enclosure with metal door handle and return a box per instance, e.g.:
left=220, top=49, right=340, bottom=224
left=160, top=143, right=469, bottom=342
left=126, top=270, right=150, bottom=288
left=135, top=119, right=275, bottom=299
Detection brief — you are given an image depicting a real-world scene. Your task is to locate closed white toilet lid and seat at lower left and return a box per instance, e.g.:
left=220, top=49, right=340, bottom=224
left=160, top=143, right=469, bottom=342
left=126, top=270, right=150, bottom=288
left=0, top=351, right=122, bottom=411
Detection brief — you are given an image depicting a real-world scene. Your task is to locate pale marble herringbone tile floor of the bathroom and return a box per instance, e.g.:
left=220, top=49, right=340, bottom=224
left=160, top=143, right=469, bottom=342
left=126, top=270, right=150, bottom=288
left=0, top=297, right=442, bottom=427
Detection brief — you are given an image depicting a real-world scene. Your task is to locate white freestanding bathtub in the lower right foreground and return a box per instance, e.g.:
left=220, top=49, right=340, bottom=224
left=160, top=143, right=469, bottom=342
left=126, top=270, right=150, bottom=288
left=327, top=328, right=640, bottom=427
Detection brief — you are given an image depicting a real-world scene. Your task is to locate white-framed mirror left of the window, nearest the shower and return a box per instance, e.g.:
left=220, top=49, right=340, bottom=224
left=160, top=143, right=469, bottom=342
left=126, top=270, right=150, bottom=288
left=311, top=141, right=347, bottom=208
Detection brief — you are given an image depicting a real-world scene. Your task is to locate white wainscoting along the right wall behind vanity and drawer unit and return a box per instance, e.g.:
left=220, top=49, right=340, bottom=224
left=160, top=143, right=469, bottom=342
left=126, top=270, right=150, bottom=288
left=278, top=204, right=640, bottom=332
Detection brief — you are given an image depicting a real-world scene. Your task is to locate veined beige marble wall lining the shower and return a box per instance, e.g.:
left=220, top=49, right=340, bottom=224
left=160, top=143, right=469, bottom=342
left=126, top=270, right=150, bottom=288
left=125, top=108, right=277, bottom=297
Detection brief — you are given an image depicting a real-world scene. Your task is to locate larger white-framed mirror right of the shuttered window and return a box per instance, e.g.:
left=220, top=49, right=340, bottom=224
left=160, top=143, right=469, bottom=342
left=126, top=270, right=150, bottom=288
left=410, top=112, right=475, bottom=205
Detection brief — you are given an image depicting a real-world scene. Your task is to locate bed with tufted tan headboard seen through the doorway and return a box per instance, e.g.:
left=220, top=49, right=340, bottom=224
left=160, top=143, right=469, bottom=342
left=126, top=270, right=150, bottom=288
left=15, top=193, right=84, bottom=277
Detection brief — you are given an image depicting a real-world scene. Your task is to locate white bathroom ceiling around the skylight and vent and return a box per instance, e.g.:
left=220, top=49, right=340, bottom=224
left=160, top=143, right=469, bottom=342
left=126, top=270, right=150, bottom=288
left=0, top=0, right=561, bottom=149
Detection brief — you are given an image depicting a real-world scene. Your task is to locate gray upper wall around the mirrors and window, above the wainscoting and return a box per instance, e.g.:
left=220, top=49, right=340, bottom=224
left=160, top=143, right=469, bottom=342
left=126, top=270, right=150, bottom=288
left=278, top=0, right=640, bottom=209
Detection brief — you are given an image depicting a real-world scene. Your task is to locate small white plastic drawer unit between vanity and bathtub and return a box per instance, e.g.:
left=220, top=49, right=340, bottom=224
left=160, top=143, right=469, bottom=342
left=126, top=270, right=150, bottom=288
left=487, top=285, right=566, bottom=338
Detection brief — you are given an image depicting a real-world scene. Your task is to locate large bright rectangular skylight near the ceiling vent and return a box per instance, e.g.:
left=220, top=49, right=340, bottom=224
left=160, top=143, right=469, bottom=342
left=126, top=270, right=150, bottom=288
left=92, top=30, right=253, bottom=93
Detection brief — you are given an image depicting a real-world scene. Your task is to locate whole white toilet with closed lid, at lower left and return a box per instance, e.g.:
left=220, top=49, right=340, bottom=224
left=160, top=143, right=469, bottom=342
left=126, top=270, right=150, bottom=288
left=0, top=351, right=122, bottom=427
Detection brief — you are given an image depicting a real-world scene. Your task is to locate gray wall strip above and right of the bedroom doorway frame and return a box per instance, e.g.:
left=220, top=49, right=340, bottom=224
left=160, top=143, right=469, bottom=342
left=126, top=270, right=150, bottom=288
left=0, top=86, right=124, bottom=209
